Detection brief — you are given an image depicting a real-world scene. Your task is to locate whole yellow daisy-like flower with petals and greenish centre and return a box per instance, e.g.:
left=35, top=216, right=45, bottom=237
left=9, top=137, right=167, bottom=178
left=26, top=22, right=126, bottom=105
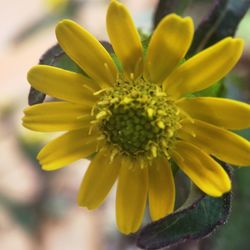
left=23, top=1, right=250, bottom=234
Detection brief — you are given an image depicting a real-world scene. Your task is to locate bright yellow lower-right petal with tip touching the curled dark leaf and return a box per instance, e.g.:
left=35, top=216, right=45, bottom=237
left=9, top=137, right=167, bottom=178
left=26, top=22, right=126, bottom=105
left=173, top=141, right=231, bottom=197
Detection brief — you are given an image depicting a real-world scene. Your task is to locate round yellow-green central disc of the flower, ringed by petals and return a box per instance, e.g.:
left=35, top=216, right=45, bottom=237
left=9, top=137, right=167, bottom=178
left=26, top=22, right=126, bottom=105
left=95, top=78, right=180, bottom=159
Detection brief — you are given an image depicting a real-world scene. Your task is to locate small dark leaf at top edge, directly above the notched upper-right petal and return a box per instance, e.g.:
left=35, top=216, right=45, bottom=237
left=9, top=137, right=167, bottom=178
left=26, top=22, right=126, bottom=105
left=153, top=0, right=191, bottom=29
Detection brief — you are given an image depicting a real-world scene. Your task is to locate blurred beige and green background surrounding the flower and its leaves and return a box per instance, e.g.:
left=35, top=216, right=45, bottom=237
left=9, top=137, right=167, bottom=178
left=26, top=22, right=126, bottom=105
left=0, top=0, right=250, bottom=250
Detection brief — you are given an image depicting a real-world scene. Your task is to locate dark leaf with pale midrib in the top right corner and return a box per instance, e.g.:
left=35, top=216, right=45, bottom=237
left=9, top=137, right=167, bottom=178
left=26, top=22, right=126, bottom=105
left=187, top=0, right=250, bottom=57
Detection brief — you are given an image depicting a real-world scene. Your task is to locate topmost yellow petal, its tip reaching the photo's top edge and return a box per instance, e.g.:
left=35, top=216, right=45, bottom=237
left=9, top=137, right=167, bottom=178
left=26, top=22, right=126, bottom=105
left=106, top=1, right=143, bottom=79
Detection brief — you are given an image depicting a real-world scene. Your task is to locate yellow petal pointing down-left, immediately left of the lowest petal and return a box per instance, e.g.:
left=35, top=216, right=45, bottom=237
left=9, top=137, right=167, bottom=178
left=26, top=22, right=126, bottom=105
left=78, top=150, right=120, bottom=209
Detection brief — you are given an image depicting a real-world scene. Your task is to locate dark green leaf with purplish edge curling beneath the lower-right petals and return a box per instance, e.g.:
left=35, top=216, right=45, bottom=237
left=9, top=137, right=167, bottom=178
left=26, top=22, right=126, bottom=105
left=137, top=164, right=231, bottom=250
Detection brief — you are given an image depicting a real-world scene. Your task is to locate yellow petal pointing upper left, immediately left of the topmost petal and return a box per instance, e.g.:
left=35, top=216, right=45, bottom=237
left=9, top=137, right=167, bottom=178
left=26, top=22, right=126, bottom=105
left=56, top=20, right=117, bottom=86
